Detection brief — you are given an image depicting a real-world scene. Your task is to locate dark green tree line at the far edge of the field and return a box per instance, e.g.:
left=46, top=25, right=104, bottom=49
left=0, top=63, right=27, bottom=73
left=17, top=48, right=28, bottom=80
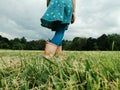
left=0, top=34, right=120, bottom=51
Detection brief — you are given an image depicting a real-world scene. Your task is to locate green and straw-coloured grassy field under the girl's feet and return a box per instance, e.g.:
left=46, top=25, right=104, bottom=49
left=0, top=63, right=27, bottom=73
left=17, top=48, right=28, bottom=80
left=0, top=50, right=120, bottom=90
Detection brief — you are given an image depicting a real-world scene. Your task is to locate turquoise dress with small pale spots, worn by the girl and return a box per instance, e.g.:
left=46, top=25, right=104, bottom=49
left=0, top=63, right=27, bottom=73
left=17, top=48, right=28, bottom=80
left=41, top=0, right=73, bottom=31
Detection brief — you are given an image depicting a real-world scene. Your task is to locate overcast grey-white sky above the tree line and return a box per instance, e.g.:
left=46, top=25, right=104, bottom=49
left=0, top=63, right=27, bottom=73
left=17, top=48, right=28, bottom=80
left=0, top=0, right=120, bottom=40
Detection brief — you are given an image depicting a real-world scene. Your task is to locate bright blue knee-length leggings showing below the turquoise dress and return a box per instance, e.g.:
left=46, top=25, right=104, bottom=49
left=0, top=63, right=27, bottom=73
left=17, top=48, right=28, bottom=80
left=51, top=25, right=66, bottom=46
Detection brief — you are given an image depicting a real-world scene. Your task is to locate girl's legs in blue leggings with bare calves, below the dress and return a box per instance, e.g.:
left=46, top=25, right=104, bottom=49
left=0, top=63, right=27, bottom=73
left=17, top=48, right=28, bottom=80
left=44, top=25, right=67, bottom=58
